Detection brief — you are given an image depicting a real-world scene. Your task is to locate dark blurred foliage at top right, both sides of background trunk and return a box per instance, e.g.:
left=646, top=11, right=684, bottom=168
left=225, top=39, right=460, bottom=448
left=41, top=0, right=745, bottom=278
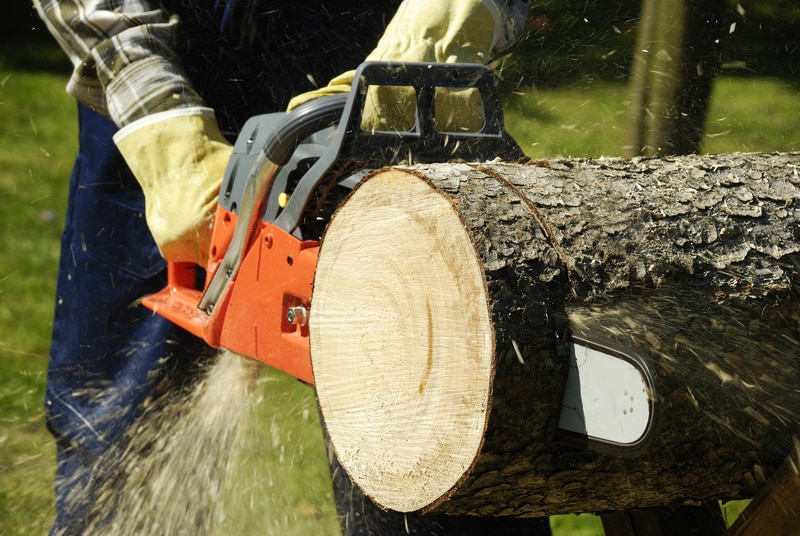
left=502, top=0, right=800, bottom=89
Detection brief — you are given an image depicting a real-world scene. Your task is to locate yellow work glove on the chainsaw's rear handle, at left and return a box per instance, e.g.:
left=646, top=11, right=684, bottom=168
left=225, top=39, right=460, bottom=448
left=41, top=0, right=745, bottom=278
left=114, top=108, right=233, bottom=266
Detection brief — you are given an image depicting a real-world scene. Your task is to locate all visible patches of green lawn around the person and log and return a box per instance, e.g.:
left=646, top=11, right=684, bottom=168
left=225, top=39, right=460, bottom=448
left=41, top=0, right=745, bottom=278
left=0, top=49, right=800, bottom=536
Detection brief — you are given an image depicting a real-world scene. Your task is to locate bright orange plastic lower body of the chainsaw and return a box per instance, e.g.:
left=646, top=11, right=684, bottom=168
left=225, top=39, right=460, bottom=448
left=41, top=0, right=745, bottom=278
left=143, top=203, right=319, bottom=384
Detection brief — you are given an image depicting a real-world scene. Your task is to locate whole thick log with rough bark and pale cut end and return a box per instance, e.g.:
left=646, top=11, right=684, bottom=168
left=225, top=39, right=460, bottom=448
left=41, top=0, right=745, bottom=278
left=309, top=154, right=800, bottom=517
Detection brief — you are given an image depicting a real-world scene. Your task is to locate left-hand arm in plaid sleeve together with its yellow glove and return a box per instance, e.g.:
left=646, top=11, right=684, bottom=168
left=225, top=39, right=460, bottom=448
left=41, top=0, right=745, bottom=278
left=35, top=0, right=232, bottom=265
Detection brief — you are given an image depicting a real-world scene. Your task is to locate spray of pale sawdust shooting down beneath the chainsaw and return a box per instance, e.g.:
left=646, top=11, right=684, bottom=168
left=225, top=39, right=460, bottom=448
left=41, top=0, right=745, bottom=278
left=85, top=352, right=259, bottom=535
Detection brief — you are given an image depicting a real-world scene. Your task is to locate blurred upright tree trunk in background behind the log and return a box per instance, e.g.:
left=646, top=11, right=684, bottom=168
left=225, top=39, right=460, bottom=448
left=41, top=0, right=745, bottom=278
left=624, top=0, right=727, bottom=156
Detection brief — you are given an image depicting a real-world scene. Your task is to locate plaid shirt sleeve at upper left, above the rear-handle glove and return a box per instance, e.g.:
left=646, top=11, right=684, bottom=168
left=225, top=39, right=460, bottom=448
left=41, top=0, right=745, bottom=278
left=34, top=0, right=205, bottom=126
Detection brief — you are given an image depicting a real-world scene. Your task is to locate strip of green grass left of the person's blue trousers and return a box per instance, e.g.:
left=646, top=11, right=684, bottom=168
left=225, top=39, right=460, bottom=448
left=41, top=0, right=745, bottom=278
left=0, top=56, right=76, bottom=535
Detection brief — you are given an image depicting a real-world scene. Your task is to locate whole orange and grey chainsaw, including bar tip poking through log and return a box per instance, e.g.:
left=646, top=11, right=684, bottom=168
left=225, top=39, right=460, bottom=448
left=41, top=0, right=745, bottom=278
left=143, top=62, right=655, bottom=450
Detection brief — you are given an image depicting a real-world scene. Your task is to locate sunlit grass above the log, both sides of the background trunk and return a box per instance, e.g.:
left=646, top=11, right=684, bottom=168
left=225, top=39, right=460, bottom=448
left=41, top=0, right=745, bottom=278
left=505, top=76, right=800, bottom=158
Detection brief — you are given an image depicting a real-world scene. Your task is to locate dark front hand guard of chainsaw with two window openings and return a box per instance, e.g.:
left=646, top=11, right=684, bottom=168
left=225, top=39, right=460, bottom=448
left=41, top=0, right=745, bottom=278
left=274, top=62, right=524, bottom=232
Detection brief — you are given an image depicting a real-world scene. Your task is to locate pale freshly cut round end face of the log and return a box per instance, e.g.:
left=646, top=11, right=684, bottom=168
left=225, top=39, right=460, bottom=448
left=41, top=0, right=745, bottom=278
left=310, top=170, right=495, bottom=512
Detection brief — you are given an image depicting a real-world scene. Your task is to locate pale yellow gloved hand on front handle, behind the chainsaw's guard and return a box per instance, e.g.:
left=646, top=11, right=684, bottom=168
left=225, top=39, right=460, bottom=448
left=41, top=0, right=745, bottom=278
left=289, top=0, right=530, bottom=131
